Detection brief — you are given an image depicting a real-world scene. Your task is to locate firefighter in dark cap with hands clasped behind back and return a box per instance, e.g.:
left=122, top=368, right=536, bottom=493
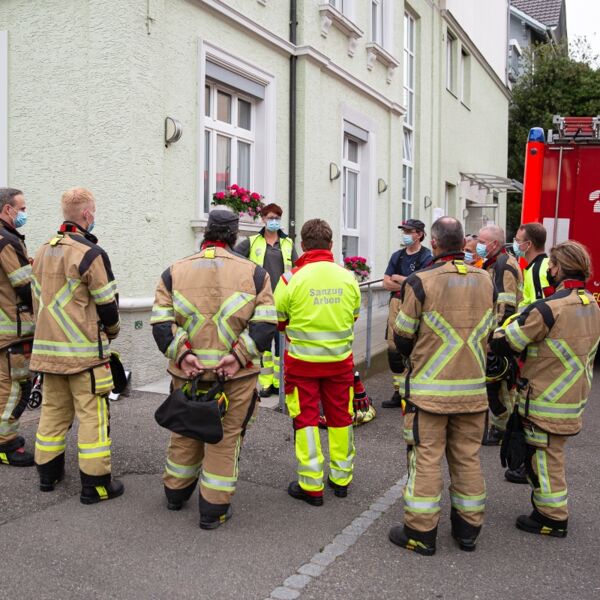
left=151, top=210, right=277, bottom=529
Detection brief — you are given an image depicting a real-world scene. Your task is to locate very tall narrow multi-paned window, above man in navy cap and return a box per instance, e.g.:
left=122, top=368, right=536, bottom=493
left=402, top=13, right=416, bottom=221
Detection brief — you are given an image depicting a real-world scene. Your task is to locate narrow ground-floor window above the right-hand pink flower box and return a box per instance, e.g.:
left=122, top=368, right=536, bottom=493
left=342, top=135, right=362, bottom=258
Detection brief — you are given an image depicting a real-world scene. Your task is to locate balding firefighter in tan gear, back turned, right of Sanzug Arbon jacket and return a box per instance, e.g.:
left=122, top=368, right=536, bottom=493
left=389, top=217, right=495, bottom=556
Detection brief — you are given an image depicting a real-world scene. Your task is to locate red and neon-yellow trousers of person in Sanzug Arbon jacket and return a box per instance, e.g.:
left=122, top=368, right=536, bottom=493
left=285, top=368, right=355, bottom=495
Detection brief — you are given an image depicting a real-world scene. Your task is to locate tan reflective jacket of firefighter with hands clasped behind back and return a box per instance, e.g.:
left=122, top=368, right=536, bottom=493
left=150, top=242, right=277, bottom=380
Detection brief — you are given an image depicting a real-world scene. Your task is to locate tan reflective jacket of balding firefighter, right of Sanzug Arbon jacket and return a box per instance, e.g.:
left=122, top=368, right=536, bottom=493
left=394, top=254, right=495, bottom=414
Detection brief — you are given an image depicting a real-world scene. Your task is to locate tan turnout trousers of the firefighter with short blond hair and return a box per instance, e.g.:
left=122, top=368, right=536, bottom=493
left=35, top=364, right=113, bottom=485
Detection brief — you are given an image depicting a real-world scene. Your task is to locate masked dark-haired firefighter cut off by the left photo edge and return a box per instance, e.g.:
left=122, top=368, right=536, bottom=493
left=0, top=188, right=33, bottom=467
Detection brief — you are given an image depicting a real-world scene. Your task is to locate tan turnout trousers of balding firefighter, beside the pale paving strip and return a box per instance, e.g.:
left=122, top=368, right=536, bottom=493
left=404, top=409, right=485, bottom=532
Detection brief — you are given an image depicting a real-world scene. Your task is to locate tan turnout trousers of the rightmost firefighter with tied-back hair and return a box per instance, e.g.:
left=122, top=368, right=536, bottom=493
left=525, top=426, right=569, bottom=521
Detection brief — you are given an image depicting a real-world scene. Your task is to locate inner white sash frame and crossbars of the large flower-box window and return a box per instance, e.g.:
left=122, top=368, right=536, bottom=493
left=202, top=80, right=257, bottom=213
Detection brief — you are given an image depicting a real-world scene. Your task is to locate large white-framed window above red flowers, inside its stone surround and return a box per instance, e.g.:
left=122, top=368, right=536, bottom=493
left=204, top=82, right=256, bottom=212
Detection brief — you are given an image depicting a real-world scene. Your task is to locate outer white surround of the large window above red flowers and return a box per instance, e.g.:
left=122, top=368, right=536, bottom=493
left=198, top=39, right=277, bottom=220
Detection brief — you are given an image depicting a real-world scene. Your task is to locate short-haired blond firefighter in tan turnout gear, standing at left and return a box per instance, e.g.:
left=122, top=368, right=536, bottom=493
left=31, top=188, right=123, bottom=504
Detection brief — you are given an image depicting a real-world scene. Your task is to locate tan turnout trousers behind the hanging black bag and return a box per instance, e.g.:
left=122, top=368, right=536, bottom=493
left=163, top=374, right=258, bottom=516
